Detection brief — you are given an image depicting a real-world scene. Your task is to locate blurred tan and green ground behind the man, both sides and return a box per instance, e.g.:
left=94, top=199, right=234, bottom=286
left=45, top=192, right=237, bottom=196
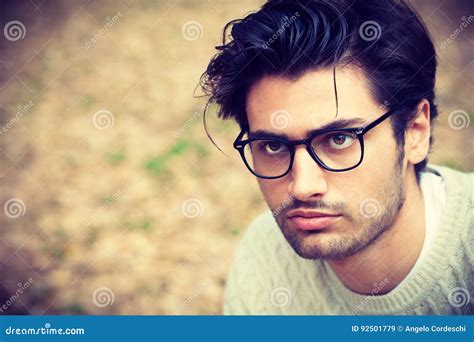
left=0, top=0, right=474, bottom=315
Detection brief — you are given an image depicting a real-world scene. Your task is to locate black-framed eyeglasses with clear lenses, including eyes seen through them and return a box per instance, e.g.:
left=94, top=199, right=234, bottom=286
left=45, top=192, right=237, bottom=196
left=234, top=110, right=395, bottom=179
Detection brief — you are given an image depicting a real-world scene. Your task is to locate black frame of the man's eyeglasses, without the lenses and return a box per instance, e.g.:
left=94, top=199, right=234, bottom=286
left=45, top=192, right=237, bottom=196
left=233, top=109, right=396, bottom=179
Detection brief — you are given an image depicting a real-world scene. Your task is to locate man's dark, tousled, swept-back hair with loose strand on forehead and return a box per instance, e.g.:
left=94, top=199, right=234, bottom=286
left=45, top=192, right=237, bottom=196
left=200, top=0, right=438, bottom=178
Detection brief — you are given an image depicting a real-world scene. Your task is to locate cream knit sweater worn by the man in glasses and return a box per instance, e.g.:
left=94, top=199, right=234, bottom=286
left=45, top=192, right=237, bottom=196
left=224, top=166, right=474, bottom=315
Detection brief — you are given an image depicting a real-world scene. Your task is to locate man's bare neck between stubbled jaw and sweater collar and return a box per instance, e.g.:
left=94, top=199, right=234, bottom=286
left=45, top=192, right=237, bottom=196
left=329, top=175, right=425, bottom=294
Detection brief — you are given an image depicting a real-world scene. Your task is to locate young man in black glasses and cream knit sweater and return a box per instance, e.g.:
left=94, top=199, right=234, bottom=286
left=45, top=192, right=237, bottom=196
left=202, top=0, right=474, bottom=315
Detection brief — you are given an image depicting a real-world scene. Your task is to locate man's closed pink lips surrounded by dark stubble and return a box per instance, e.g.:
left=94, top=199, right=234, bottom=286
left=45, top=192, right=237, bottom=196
left=287, top=210, right=341, bottom=231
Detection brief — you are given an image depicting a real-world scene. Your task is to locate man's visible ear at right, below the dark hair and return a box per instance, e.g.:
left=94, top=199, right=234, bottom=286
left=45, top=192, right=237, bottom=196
left=405, top=99, right=431, bottom=165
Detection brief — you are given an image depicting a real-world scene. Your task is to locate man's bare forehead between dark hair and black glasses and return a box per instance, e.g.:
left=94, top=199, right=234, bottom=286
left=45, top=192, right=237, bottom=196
left=246, top=68, right=381, bottom=139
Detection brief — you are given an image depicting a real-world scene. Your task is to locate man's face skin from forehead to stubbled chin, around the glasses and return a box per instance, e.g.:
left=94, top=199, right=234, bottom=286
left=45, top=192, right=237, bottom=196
left=247, top=68, right=406, bottom=259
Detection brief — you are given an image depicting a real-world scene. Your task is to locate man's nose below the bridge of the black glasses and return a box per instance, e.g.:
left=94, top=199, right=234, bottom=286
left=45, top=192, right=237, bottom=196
left=288, top=146, right=328, bottom=201
